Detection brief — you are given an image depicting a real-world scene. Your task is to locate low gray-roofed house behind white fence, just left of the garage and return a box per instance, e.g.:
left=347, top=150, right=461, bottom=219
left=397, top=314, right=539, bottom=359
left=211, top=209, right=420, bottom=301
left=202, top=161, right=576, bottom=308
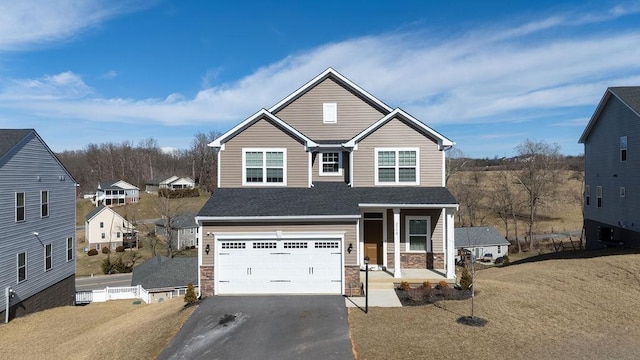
left=131, top=256, right=198, bottom=302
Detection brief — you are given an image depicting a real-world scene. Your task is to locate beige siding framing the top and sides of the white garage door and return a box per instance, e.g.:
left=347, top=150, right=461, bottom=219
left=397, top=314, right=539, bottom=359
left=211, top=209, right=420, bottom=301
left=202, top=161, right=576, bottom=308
left=202, top=222, right=358, bottom=266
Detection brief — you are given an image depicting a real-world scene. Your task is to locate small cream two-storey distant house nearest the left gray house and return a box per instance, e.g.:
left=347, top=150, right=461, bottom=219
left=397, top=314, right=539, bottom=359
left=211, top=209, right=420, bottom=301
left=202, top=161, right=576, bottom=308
left=84, top=206, right=138, bottom=251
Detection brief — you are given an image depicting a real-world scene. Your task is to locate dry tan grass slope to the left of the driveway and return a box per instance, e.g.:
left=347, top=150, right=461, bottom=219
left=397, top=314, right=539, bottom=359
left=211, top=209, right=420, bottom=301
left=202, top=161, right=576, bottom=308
left=0, top=298, right=195, bottom=360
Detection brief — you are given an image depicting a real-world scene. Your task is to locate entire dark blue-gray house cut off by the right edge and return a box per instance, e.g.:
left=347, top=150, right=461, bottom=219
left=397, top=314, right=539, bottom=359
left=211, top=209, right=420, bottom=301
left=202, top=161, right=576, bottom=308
left=579, top=86, right=640, bottom=249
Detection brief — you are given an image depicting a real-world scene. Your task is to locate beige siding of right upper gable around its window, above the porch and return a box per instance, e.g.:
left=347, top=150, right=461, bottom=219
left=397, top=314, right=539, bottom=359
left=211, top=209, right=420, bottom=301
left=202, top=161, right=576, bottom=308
left=351, top=119, right=444, bottom=186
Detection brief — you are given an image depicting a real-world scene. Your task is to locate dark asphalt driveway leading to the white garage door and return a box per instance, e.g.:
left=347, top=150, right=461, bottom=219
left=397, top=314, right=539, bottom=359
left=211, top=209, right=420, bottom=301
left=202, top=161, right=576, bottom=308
left=158, top=296, right=353, bottom=360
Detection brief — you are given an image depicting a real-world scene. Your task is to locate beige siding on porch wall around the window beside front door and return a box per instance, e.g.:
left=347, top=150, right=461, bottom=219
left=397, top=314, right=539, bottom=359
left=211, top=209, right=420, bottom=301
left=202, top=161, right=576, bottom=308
left=387, top=209, right=445, bottom=253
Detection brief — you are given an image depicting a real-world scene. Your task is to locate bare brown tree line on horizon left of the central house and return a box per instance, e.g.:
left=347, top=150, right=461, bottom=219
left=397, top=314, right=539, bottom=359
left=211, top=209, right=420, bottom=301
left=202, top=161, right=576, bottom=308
left=56, top=131, right=220, bottom=194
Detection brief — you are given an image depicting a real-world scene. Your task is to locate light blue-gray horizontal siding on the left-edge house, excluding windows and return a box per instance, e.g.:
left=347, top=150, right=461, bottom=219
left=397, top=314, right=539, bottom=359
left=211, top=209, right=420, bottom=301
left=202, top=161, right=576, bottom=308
left=0, top=134, right=76, bottom=310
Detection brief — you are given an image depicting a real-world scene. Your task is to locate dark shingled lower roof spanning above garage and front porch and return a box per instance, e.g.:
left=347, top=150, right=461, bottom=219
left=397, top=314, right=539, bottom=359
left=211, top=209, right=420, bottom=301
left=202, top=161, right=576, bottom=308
left=198, top=182, right=457, bottom=217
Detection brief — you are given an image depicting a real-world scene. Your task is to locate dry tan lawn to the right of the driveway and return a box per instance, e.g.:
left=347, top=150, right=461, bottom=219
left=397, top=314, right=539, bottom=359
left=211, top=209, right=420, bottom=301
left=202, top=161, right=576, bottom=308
left=349, top=252, right=640, bottom=359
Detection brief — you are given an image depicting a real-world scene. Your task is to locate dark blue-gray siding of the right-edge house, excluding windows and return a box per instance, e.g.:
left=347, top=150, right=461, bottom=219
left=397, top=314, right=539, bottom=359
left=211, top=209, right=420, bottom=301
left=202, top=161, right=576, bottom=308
left=584, top=96, right=640, bottom=231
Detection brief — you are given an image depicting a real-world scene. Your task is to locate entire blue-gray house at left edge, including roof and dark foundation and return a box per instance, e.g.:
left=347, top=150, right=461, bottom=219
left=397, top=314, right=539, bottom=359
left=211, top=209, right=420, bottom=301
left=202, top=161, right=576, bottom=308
left=0, top=129, right=76, bottom=320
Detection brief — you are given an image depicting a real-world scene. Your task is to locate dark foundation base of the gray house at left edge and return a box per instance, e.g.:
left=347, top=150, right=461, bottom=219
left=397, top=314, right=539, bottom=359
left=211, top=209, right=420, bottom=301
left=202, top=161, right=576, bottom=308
left=0, top=275, right=76, bottom=320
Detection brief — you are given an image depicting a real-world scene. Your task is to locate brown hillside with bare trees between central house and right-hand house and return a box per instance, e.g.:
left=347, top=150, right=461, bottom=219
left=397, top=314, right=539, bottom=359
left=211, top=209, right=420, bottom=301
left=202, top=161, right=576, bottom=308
left=445, top=139, right=584, bottom=252
